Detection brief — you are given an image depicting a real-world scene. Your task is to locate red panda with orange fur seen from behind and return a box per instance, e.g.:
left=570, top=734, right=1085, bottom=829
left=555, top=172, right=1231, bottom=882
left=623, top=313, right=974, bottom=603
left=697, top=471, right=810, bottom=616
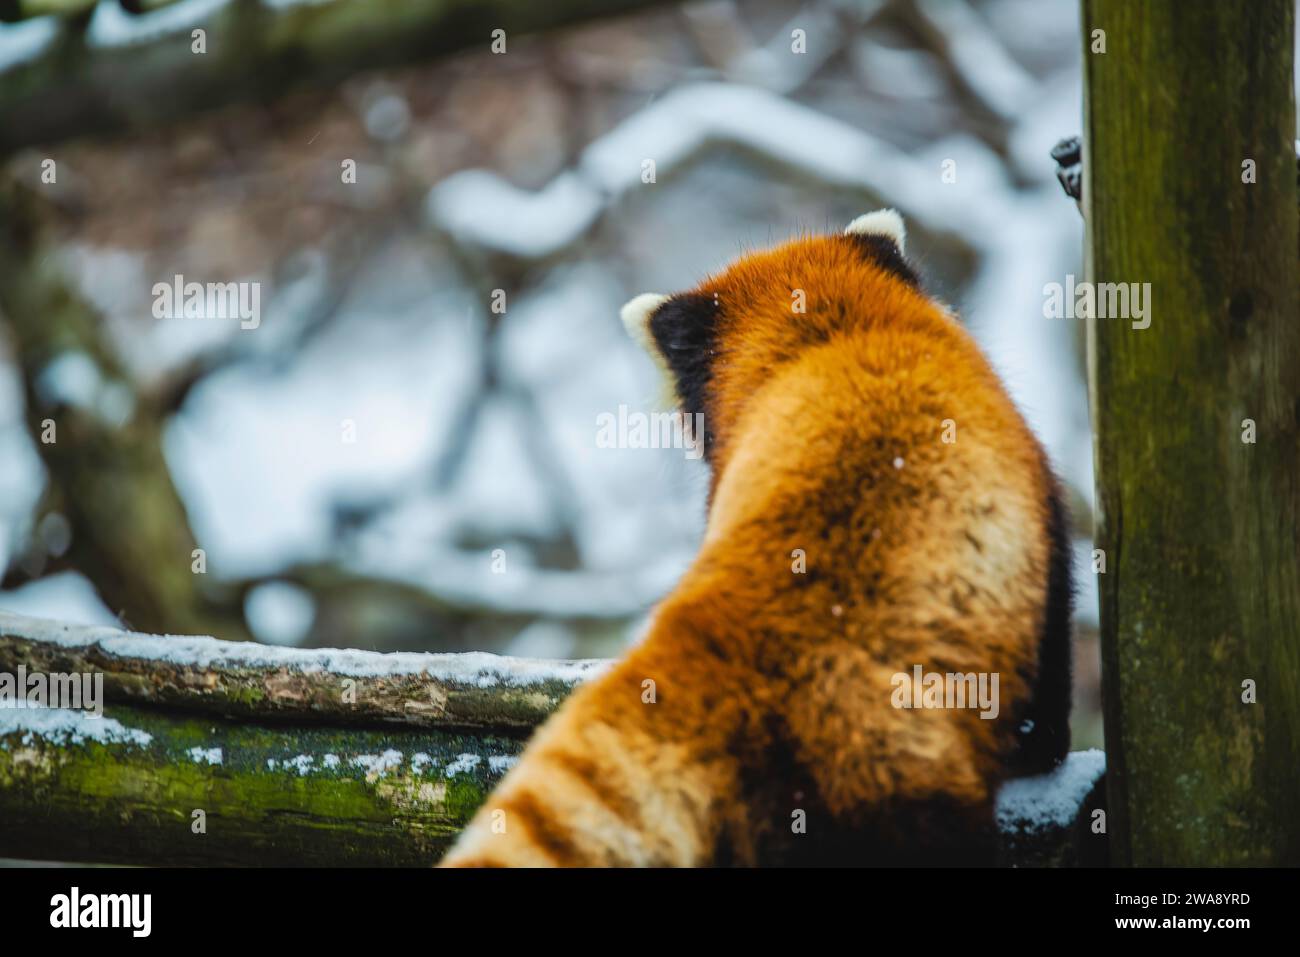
left=443, top=209, right=1071, bottom=867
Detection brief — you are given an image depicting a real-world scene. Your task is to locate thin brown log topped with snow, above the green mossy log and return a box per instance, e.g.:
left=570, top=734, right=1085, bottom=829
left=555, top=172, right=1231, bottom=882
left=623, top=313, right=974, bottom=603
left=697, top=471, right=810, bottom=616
left=0, top=611, right=605, bottom=731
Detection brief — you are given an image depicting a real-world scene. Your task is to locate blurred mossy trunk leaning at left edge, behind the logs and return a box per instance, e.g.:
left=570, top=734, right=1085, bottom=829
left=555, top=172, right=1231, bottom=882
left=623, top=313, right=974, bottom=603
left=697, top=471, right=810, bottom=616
left=0, top=179, right=247, bottom=638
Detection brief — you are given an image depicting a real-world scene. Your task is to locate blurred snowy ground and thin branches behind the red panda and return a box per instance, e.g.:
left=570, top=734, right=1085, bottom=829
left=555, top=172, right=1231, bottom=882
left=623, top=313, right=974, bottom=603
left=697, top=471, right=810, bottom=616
left=0, top=0, right=1100, bottom=746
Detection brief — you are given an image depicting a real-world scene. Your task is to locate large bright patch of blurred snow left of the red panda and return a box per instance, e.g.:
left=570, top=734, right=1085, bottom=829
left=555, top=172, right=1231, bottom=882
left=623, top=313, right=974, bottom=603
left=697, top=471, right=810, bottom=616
left=164, top=280, right=475, bottom=577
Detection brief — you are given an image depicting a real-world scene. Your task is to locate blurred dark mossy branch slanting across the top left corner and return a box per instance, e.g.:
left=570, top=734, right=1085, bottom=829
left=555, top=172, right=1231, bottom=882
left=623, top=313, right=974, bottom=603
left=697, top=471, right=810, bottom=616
left=0, top=0, right=676, bottom=155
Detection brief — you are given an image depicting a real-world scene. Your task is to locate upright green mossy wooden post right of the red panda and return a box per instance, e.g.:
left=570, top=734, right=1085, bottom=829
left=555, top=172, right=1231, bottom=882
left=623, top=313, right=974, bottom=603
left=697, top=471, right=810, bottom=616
left=1083, top=0, right=1300, bottom=866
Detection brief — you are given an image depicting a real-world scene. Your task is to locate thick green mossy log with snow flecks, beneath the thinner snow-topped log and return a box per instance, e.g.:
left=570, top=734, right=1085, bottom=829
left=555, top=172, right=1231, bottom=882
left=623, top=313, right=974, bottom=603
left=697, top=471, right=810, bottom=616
left=0, top=705, right=523, bottom=866
